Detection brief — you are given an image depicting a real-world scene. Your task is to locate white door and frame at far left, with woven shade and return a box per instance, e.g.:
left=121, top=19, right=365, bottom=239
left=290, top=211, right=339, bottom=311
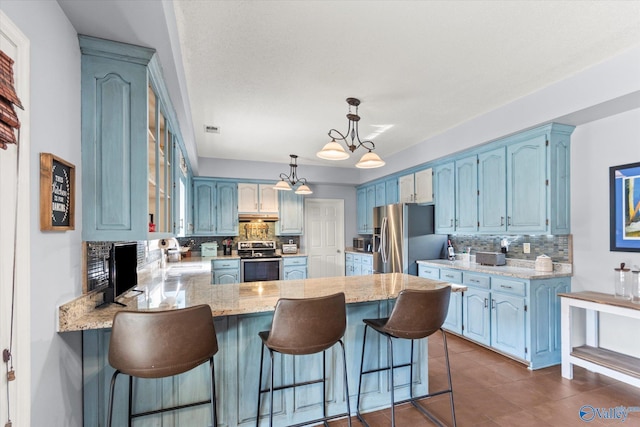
left=0, top=10, right=30, bottom=426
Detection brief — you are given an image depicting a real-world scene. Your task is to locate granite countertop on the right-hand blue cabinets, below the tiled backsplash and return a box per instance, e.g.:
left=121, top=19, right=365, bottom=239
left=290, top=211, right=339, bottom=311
left=416, top=258, right=573, bottom=279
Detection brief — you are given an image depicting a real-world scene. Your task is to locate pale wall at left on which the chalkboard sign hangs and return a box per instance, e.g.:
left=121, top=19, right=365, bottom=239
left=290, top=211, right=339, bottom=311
left=0, top=0, right=82, bottom=426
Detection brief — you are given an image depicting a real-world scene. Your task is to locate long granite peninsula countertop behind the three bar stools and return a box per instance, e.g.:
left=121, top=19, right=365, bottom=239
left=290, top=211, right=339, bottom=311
left=58, top=262, right=466, bottom=332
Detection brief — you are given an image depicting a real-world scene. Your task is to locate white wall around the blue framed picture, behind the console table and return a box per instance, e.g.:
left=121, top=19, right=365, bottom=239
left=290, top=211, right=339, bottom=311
left=571, top=109, right=640, bottom=357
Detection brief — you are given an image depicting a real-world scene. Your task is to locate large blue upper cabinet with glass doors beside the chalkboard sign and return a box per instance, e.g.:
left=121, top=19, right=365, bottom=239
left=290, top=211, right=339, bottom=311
left=79, top=36, right=182, bottom=241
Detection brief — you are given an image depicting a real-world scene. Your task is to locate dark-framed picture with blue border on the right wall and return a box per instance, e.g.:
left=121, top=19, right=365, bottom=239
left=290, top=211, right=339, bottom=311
left=609, top=162, right=640, bottom=252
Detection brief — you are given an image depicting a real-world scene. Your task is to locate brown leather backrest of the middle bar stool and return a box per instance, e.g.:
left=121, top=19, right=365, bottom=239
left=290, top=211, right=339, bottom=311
left=266, top=292, right=347, bottom=355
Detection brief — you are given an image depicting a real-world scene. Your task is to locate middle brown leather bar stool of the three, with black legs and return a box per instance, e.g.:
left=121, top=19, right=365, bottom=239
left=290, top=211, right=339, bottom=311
left=256, top=292, right=351, bottom=427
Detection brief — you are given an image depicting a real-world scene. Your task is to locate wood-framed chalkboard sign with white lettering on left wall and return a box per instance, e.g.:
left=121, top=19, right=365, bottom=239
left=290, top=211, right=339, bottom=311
left=40, top=153, right=76, bottom=231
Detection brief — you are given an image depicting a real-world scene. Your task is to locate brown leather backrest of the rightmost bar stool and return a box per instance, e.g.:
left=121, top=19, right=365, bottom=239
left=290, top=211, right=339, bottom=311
left=381, top=286, right=451, bottom=339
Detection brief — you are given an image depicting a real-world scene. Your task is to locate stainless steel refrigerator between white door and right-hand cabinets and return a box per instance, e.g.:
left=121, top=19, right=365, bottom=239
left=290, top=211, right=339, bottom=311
left=373, top=203, right=447, bottom=276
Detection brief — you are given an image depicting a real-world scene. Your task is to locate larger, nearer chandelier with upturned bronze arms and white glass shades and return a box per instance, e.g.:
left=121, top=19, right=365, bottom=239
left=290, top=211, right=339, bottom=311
left=316, top=98, right=385, bottom=169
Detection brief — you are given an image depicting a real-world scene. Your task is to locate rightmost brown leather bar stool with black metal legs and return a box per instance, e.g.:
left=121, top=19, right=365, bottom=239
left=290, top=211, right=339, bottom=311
left=356, top=286, right=456, bottom=426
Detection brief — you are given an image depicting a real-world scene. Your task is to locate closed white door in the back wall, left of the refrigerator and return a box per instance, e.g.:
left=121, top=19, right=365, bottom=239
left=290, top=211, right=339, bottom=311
left=304, top=199, right=344, bottom=278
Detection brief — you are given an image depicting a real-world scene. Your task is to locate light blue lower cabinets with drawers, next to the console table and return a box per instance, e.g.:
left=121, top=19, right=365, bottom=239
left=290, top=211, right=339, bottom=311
left=418, top=264, right=571, bottom=369
